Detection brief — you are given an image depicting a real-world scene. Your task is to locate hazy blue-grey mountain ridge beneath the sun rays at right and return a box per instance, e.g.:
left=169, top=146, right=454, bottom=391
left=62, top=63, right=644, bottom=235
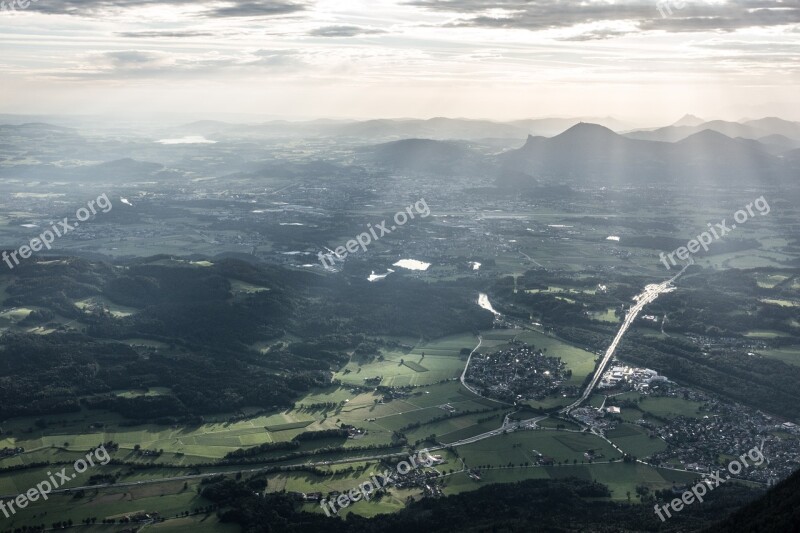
left=362, top=123, right=800, bottom=186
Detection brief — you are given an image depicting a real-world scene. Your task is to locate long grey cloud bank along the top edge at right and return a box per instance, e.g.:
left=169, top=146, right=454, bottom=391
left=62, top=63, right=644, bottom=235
left=406, top=0, right=800, bottom=33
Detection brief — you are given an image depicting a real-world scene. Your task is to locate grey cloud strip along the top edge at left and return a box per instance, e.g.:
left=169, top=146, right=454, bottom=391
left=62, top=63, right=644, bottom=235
left=29, top=0, right=308, bottom=18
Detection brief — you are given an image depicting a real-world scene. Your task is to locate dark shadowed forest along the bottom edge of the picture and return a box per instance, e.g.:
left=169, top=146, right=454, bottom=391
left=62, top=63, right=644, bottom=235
left=202, top=479, right=764, bottom=533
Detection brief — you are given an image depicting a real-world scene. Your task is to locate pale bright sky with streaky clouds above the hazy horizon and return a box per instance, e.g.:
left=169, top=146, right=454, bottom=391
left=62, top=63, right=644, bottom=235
left=0, top=0, right=800, bottom=122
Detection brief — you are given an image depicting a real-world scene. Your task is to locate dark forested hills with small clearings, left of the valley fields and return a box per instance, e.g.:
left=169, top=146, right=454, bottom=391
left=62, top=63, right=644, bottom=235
left=0, top=256, right=492, bottom=422
